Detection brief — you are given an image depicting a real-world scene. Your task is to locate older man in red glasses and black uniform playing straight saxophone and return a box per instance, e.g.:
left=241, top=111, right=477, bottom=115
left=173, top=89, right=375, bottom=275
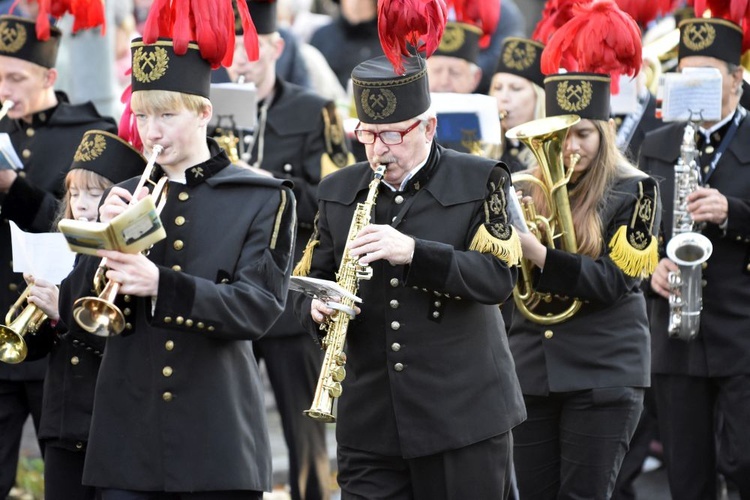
left=294, top=46, right=525, bottom=500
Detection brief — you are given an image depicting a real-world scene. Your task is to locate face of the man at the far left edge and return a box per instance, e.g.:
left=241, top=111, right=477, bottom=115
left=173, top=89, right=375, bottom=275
left=0, top=56, right=57, bottom=119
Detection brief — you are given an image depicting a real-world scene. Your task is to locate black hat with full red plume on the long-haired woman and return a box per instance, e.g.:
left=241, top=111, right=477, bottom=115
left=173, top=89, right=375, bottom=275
left=541, top=0, right=643, bottom=120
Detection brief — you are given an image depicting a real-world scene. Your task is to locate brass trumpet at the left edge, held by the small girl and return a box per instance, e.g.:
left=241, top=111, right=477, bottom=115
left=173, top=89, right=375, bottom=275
left=0, top=286, right=47, bottom=365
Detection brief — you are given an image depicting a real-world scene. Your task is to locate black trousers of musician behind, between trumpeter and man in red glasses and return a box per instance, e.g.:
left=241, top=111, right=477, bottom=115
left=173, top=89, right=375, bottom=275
left=253, top=333, right=331, bottom=500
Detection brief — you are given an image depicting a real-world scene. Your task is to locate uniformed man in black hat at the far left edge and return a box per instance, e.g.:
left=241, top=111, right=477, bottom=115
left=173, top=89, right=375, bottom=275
left=0, top=16, right=116, bottom=498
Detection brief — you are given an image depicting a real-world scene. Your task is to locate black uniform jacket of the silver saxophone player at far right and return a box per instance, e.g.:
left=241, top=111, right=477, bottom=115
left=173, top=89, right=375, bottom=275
left=640, top=111, right=750, bottom=377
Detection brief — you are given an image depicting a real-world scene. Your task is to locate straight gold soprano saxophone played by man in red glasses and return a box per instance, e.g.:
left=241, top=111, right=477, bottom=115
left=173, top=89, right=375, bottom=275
left=304, top=165, right=386, bottom=422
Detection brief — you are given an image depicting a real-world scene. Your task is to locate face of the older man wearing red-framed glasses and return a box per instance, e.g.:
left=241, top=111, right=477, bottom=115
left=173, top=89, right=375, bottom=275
left=358, top=118, right=437, bottom=188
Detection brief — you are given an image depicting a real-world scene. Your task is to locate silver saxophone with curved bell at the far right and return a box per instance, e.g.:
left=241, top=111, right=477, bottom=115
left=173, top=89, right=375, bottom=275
left=667, top=122, right=713, bottom=340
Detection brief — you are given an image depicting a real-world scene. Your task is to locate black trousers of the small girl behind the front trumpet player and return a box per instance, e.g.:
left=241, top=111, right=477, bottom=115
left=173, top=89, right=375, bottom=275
left=44, top=443, right=98, bottom=500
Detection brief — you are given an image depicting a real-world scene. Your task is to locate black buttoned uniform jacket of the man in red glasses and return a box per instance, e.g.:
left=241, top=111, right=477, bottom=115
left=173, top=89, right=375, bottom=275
left=294, top=146, right=525, bottom=458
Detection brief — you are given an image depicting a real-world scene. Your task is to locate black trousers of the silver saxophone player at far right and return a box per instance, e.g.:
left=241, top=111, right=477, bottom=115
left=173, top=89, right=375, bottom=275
left=653, top=375, right=750, bottom=500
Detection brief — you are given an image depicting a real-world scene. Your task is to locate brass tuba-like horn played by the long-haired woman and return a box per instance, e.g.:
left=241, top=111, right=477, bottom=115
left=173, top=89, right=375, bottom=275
left=505, top=115, right=582, bottom=325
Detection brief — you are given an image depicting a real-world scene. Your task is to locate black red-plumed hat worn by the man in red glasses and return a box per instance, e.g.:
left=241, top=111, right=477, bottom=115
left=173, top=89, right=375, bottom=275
left=352, top=0, right=447, bottom=124
